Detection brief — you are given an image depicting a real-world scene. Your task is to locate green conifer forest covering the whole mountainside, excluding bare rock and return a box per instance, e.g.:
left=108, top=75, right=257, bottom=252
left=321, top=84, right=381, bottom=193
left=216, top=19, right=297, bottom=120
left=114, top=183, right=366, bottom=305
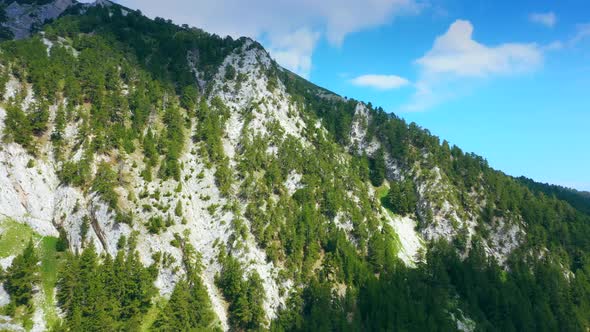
left=0, top=1, right=590, bottom=331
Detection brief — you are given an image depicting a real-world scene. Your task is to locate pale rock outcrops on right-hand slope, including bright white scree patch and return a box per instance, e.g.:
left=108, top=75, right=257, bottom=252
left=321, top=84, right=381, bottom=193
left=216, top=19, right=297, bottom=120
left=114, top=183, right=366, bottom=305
left=348, top=103, right=525, bottom=264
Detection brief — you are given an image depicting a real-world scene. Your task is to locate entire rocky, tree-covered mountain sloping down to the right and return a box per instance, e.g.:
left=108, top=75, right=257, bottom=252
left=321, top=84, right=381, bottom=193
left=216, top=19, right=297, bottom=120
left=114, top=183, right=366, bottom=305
left=0, top=0, right=590, bottom=331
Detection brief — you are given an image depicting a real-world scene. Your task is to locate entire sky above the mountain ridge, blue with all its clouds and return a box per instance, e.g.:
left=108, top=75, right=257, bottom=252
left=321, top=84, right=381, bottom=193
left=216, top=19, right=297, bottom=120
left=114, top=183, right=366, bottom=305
left=112, top=0, right=590, bottom=191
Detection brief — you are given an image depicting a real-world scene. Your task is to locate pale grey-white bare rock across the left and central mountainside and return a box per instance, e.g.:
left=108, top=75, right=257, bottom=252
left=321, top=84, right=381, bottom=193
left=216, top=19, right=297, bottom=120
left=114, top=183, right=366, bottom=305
left=0, top=41, right=305, bottom=330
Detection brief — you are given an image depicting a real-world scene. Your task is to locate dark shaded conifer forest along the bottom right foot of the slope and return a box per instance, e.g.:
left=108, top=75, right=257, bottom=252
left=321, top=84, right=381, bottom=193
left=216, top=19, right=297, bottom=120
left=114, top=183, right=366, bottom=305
left=271, top=243, right=590, bottom=331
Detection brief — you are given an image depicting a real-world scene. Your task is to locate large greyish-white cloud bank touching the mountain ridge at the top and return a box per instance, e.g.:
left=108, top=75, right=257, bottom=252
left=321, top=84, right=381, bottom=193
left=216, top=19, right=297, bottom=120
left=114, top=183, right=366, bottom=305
left=116, top=0, right=422, bottom=75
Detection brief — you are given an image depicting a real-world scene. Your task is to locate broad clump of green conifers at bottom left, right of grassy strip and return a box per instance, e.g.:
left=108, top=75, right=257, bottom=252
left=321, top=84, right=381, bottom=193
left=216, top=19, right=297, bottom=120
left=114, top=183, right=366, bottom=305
left=57, top=246, right=157, bottom=331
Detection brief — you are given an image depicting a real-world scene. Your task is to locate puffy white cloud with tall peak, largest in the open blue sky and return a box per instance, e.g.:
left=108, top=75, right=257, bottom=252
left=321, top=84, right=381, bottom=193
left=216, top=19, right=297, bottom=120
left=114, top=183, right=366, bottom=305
left=402, top=20, right=543, bottom=111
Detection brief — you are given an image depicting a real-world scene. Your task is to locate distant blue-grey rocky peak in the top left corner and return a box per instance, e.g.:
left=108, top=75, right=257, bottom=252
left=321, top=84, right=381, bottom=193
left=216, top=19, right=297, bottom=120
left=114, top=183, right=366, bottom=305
left=2, top=0, right=76, bottom=39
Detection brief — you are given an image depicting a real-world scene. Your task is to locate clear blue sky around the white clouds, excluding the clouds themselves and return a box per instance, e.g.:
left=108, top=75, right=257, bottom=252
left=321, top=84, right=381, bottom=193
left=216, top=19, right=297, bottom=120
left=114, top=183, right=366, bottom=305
left=309, top=1, right=590, bottom=190
